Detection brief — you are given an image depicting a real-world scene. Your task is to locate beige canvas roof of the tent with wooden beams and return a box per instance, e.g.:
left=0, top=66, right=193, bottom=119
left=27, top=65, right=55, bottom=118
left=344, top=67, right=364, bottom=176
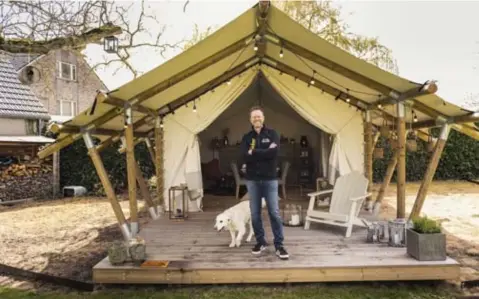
left=40, top=4, right=479, bottom=161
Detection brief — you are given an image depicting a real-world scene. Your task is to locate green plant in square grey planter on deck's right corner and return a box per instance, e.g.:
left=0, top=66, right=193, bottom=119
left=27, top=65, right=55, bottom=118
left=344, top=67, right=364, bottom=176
left=406, top=217, right=447, bottom=261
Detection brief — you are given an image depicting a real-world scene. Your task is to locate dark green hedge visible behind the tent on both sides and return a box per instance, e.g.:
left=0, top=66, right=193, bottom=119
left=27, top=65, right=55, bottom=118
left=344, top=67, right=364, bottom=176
left=60, top=130, right=479, bottom=195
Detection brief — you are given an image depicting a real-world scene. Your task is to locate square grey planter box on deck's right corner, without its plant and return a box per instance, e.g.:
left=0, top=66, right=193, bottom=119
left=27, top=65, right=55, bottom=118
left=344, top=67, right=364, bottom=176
left=406, top=229, right=447, bottom=261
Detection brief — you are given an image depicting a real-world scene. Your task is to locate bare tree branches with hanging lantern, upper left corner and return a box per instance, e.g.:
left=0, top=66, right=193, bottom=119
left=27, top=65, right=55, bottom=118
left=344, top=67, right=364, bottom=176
left=0, top=0, right=180, bottom=77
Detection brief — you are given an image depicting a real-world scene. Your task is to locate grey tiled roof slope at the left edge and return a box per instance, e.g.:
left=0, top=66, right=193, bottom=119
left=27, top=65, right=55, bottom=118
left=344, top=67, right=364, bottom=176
left=0, top=52, right=50, bottom=119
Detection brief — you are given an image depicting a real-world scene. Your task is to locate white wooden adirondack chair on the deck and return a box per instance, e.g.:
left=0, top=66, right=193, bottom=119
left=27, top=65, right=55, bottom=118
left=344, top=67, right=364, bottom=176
left=304, top=172, right=371, bottom=238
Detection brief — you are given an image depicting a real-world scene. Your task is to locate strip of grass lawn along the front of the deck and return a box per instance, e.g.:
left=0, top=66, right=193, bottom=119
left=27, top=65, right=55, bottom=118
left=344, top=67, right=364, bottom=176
left=0, top=283, right=464, bottom=299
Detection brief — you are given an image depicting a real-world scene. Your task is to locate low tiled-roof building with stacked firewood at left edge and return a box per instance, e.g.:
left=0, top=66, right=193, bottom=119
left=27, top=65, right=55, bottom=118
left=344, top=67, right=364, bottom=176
left=0, top=52, right=55, bottom=201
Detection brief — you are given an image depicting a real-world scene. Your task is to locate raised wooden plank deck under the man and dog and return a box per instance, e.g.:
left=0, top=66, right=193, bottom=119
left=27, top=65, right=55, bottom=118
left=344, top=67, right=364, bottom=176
left=93, top=212, right=459, bottom=284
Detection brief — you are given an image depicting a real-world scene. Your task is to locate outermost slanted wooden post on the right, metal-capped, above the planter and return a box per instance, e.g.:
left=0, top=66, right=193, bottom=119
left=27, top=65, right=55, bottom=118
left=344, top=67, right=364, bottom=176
left=409, top=123, right=450, bottom=219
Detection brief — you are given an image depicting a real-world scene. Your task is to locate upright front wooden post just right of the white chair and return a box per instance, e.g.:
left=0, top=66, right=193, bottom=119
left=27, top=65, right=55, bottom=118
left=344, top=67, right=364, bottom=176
left=396, top=102, right=406, bottom=218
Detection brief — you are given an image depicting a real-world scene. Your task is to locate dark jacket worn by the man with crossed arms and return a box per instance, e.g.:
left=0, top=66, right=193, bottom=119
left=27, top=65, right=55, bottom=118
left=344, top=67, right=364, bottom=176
left=240, top=126, right=279, bottom=181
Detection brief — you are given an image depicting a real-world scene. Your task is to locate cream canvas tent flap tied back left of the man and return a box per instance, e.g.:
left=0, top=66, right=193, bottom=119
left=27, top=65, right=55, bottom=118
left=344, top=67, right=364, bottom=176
left=164, top=68, right=257, bottom=212
